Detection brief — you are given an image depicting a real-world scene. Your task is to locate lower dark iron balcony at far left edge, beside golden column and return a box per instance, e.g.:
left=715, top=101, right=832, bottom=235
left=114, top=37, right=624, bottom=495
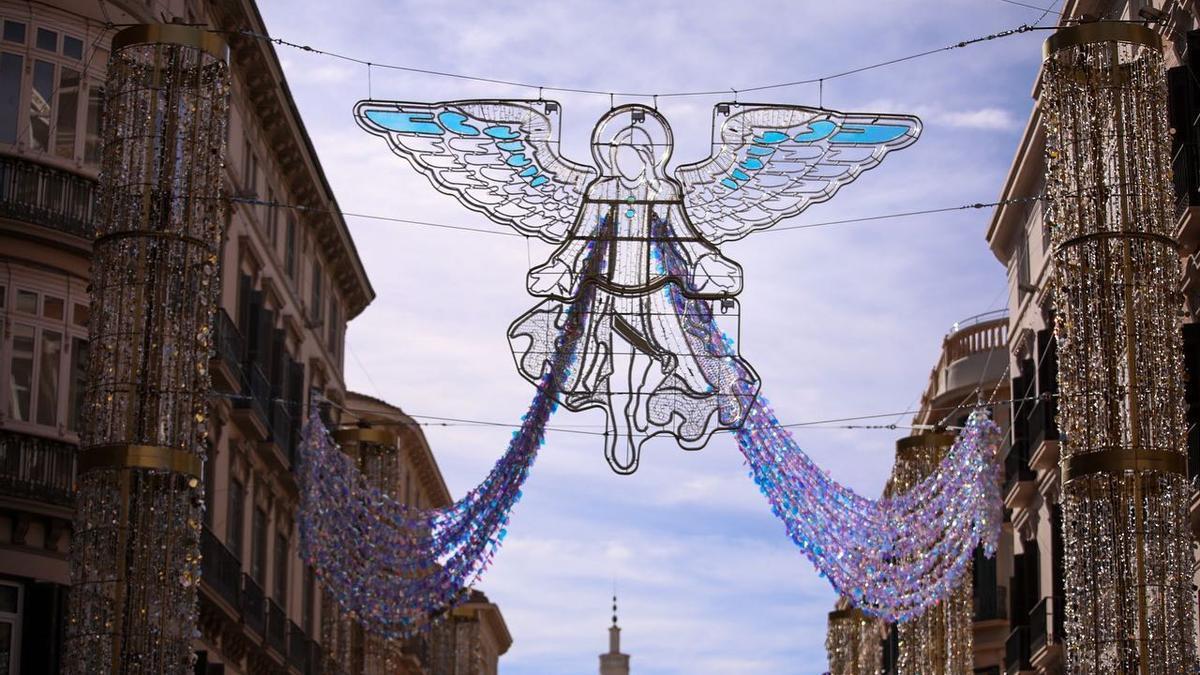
left=0, top=430, right=78, bottom=507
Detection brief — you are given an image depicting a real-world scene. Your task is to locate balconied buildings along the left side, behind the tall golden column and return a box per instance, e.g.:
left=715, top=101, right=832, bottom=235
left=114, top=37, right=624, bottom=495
left=0, top=0, right=511, bottom=675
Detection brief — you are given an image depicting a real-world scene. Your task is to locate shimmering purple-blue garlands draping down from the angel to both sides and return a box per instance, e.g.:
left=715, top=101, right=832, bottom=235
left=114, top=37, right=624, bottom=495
left=300, top=221, right=1001, bottom=637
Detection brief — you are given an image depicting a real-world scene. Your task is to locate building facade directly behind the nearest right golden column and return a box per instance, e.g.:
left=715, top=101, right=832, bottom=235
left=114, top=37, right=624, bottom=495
left=986, top=0, right=1200, bottom=674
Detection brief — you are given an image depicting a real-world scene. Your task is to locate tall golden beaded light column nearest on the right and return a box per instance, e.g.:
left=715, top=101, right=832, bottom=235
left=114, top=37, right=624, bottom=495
left=1042, top=22, right=1196, bottom=675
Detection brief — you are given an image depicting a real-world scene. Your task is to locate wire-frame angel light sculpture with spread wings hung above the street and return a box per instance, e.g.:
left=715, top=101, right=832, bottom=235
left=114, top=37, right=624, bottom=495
left=355, top=101, right=920, bottom=473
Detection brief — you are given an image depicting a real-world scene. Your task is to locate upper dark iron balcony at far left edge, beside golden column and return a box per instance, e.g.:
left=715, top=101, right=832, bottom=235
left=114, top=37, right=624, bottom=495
left=0, top=156, right=96, bottom=241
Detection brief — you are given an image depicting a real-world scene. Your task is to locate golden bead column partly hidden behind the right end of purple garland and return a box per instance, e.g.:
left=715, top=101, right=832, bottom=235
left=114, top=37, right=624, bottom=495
left=884, top=432, right=974, bottom=675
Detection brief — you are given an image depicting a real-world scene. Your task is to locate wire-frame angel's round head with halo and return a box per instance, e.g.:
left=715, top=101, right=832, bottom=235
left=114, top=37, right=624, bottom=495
left=592, top=103, right=673, bottom=184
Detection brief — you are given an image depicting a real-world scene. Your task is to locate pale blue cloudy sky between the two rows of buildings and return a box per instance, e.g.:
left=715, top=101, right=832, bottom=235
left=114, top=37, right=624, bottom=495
left=260, top=0, right=1056, bottom=675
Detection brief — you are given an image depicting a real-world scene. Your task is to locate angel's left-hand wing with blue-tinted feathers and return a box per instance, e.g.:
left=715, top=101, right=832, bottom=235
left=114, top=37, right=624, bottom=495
left=354, top=101, right=596, bottom=243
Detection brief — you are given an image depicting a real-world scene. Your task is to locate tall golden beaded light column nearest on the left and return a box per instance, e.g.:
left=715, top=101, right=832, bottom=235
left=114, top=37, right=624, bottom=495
left=65, top=24, right=229, bottom=675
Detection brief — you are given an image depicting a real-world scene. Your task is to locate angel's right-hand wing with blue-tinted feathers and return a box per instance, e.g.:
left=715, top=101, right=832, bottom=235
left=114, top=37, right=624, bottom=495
left=676, top=103, right=920, bottom=244
